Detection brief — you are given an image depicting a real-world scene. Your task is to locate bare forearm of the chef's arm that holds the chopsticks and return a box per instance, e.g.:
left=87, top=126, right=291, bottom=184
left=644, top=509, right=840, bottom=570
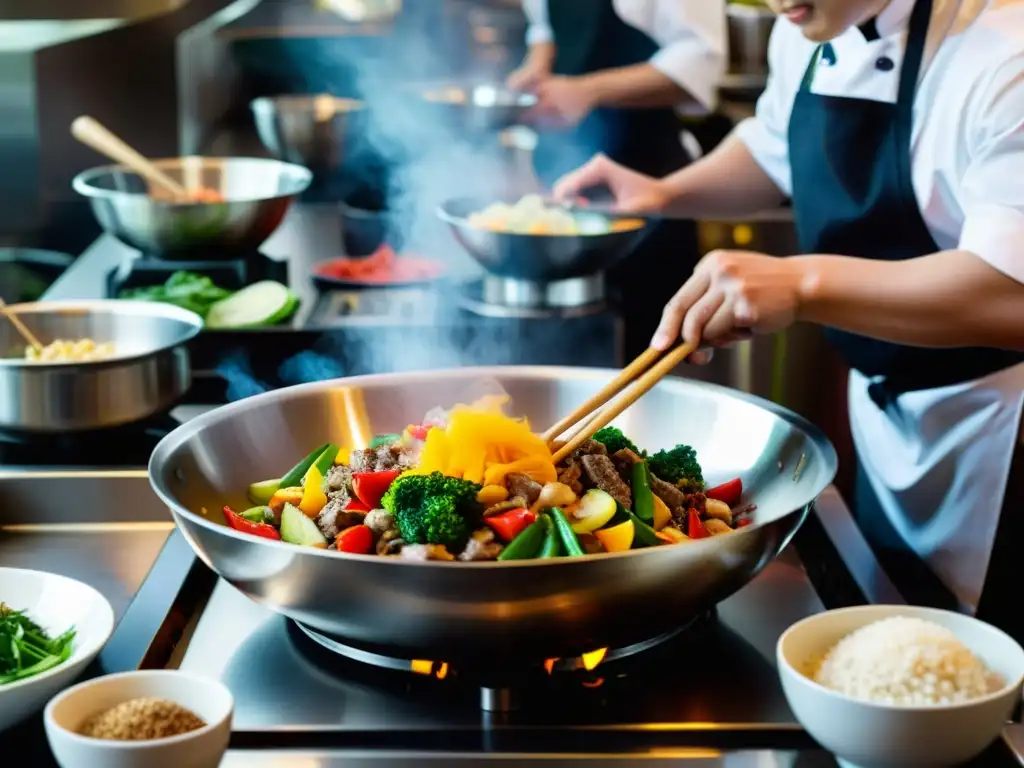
left=793, top=251, right=1024, bottom=350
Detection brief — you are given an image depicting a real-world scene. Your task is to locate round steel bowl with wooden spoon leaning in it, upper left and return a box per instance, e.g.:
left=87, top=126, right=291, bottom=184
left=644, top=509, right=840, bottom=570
left=72, top=158, right=312, bottom=259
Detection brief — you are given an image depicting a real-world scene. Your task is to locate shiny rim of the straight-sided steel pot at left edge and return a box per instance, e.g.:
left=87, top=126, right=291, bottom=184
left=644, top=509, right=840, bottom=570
left=0, top=299, right=204, bottom=371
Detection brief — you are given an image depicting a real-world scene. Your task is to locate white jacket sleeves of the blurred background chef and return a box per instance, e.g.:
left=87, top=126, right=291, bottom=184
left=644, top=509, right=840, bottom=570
left=522, top=0, right=729, bottom=114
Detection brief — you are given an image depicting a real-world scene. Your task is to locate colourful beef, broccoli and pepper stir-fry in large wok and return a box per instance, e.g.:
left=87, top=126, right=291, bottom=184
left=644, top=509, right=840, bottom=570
left=224, top=397, right=754, bottom=561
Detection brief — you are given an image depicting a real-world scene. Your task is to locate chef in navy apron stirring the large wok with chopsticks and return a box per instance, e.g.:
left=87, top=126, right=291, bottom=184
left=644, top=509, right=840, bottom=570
left=556, top=0, right=1024, bottom=641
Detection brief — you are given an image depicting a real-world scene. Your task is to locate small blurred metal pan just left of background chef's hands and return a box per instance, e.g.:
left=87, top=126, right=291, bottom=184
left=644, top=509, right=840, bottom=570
left=419, top=83, right=537, bottom=132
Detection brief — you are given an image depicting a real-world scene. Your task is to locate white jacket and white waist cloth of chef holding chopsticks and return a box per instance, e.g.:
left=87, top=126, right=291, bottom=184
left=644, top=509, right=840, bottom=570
left=737, top=0, right=1024, bottom=609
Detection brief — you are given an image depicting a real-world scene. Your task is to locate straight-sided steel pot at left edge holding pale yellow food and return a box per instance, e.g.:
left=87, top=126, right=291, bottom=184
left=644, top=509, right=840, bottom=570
left=0, top=300, right=203, bottom=433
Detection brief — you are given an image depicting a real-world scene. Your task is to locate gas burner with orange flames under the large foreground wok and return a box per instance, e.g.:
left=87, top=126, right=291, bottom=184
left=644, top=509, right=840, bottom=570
left=294, top=609, right=715, bottom=713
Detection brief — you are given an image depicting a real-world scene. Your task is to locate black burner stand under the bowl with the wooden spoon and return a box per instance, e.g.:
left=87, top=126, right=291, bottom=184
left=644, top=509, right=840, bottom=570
left=106, top=251, right=288, bottom=298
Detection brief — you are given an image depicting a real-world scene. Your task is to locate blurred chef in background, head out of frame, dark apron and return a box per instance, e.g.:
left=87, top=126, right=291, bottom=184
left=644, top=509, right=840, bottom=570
left=508, top=0, right=727, bottom=354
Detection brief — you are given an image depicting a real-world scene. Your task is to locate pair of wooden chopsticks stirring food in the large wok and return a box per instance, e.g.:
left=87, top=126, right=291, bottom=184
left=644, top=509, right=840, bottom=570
left=541, top=344, right=697, bottom=464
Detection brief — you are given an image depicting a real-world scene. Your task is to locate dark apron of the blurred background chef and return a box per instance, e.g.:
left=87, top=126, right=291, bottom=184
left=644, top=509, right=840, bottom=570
left=534, top=0, right=697, bottom=359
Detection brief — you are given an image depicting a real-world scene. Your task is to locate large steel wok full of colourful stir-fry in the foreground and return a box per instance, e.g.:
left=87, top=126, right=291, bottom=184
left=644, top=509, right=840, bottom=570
left=150, top=368, right=836, bottom=662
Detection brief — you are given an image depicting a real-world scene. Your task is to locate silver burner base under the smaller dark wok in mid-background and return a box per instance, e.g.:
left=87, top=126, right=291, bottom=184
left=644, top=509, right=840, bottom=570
left=459, top=274, right=607, bottom=318
